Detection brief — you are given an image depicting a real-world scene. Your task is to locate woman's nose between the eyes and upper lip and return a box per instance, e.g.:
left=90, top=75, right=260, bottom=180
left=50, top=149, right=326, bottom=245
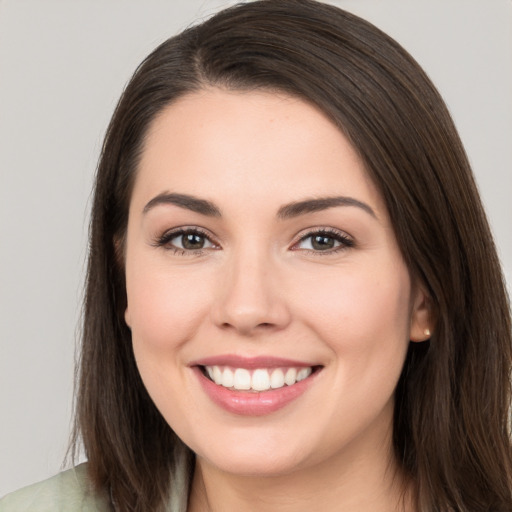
left=211, top=249, right=291, bottom=337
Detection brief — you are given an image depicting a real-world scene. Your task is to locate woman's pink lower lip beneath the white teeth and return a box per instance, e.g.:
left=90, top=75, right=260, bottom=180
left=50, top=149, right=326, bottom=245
left=192, top=366, right=318, bottom=416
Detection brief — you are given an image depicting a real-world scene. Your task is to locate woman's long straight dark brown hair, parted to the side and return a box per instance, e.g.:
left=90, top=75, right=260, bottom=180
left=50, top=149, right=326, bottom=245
left=70, top=0, right=512, bottom=512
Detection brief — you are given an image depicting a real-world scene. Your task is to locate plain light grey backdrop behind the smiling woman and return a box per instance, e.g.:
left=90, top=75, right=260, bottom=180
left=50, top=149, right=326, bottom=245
left=0, top=0, right=512, bottom=495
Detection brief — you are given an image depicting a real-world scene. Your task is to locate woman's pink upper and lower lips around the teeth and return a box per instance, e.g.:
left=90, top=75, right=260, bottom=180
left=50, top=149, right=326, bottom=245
left=189, top=355, right=318, bottom=416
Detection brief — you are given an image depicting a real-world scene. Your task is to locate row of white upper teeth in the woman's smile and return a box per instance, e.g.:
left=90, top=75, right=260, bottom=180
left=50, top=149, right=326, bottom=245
left=205, top=366, right=313, bottom=391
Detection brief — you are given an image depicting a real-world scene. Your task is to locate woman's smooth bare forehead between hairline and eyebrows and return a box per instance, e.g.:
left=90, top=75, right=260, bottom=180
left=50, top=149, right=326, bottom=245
left=134, top=89, right=382, bottom=215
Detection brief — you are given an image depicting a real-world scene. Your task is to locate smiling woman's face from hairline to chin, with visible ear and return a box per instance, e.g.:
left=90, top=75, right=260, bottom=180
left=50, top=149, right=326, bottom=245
left=125, top=89, right=427, bottom=475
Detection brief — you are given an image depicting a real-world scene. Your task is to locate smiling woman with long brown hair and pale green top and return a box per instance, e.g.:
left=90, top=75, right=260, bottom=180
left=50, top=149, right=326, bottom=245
left=2, top=0, right=512, bottom=512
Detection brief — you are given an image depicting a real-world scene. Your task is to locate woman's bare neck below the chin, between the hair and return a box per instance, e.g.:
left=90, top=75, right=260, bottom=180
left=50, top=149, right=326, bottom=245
left=188, top=414, right=414, bottom=512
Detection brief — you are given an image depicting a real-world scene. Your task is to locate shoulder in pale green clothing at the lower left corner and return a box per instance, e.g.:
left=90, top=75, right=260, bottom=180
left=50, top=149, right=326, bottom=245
left=0, top=464, right=110, bottom=512
